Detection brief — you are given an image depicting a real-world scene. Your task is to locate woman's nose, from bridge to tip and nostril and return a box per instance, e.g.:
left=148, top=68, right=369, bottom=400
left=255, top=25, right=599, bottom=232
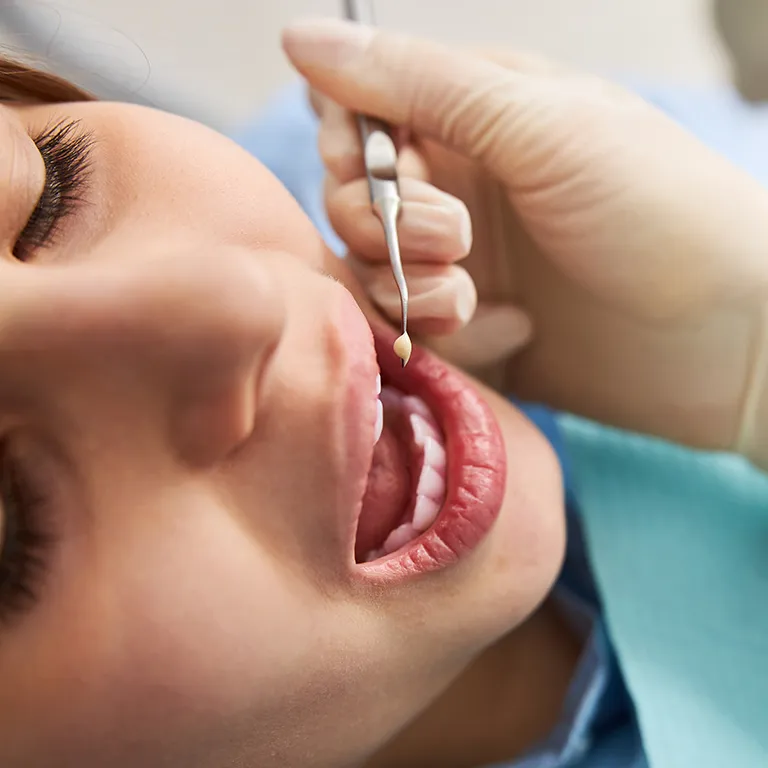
left=0, top=249, right=287, bottom=467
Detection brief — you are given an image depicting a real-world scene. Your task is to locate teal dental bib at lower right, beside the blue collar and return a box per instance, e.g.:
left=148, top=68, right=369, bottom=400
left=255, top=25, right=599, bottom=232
left=559, top=416, right=768, bottom=768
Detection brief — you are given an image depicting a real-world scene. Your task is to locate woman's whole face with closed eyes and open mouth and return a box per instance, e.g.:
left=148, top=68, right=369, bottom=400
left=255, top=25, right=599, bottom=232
left=0, top=103, right=563, bottom=768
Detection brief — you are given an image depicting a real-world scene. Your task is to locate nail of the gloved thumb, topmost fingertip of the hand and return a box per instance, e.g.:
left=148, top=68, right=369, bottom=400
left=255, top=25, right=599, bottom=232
left=283, top=19, right=374, bottom=67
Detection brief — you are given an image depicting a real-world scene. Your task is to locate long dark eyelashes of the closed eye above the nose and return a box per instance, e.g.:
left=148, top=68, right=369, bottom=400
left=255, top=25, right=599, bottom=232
left=13, top=120, right=94, bottom=261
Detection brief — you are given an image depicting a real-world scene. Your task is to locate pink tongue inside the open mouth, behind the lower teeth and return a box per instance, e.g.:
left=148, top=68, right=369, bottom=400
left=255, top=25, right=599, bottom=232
left=355, top=420, right=411, bottom=562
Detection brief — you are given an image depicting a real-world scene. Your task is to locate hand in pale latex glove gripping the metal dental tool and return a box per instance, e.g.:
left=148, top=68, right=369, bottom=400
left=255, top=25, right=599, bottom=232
left=284, top=21, right=768, bottom=463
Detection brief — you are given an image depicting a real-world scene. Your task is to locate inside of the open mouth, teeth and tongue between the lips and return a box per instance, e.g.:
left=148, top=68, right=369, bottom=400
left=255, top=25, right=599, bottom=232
left=355, top=376, right=447, bottom=563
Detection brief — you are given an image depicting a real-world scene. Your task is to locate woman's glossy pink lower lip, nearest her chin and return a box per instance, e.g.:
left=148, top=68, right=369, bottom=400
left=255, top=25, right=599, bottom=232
left=356, top=332, right=507, bottom=581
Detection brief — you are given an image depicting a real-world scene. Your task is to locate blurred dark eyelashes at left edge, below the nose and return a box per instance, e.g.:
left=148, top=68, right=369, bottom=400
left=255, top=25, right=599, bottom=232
left=0, top=446, right=53, bottom=625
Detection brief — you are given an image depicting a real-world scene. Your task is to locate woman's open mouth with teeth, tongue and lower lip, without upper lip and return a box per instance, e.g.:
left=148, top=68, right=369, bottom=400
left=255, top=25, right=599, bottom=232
left=354, top=324, right=507, bottom=579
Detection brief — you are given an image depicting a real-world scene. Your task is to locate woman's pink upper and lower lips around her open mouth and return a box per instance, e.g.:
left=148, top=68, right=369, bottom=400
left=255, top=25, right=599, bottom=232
left=344, top=292, right=507, bottom=582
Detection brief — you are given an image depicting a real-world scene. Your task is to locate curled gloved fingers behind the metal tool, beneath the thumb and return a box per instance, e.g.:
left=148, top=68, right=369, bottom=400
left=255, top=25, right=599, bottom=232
left=311, top=92, right=531, bottom=372
